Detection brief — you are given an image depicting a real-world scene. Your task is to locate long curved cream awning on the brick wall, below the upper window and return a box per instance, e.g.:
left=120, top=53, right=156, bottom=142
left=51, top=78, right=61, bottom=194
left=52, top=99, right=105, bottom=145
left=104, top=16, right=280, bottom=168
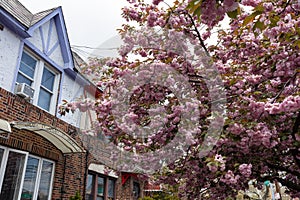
left=11, top=122, right=85, bottom=153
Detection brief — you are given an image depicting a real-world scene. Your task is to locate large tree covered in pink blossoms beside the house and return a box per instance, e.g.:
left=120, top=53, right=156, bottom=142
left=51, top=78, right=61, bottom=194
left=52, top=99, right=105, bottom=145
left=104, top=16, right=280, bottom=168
left=61, top=0, right=300, bottom=199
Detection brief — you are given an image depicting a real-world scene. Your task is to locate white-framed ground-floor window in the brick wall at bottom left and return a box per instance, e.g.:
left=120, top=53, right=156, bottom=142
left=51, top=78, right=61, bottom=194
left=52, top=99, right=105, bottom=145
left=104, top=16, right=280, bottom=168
left=0, top=147, right=54, bottom=200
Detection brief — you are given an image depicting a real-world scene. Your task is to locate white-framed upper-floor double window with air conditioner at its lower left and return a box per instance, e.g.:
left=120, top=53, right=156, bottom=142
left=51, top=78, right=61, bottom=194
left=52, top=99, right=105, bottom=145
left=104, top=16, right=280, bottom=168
left=16, top=51, right=59, bottom=114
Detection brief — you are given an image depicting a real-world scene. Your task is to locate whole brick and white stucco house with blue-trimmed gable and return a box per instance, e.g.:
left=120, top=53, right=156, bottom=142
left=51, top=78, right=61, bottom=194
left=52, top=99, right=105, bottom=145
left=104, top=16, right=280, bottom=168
left=0, top=0, right=144, bottom=200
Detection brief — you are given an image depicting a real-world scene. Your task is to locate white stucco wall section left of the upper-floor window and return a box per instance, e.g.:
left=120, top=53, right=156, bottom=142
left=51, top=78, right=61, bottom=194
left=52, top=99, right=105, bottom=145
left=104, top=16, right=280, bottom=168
left=0, top=26, right=21, bottom=91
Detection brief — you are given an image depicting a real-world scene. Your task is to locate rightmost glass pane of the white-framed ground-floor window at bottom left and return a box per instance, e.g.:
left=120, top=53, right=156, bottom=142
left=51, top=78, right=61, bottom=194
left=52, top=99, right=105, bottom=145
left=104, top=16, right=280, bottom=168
left=37, top=161, right=53, bottom=200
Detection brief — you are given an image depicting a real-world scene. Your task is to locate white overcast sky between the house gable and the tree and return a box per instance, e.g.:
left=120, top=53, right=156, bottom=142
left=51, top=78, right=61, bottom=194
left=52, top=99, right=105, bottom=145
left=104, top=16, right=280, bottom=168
left=19, top=0, right=127, bottom=56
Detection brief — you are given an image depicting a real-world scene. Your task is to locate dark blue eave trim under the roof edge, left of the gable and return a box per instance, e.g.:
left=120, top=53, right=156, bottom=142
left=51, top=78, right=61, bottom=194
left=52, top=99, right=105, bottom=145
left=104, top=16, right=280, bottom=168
left=0, top=8, right=30, bottom=38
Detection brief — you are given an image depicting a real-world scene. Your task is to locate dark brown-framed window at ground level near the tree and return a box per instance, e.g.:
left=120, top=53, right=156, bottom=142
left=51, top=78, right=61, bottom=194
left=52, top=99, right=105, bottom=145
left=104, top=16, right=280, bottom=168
left=86, top=172, right=116, bottom=200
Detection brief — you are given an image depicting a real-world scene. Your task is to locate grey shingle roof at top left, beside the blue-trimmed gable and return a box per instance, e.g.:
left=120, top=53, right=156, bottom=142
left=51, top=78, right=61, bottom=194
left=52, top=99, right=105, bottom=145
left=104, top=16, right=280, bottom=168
left=0, top=0, right=56, bottom=28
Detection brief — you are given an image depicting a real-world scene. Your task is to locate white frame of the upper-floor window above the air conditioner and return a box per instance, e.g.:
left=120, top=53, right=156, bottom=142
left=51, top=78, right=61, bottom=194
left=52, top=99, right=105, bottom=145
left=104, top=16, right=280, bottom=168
left=16, top=49, right=61, bottom=115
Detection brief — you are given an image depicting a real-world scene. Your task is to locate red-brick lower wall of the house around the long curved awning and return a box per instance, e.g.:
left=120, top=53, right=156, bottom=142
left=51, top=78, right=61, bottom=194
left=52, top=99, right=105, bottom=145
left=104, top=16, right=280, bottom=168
left=0, top=88, right=86, bottom=200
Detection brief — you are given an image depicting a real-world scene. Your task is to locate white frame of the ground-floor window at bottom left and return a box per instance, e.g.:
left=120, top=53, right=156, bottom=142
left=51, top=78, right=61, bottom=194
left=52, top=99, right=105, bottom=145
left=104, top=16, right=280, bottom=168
left=0, top=145, right=55, bottom=200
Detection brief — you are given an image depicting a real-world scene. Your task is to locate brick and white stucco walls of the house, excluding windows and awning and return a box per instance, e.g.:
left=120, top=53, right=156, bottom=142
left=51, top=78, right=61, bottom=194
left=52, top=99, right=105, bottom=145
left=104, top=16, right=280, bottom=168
left=0, top=2, right=143, bottom=200
